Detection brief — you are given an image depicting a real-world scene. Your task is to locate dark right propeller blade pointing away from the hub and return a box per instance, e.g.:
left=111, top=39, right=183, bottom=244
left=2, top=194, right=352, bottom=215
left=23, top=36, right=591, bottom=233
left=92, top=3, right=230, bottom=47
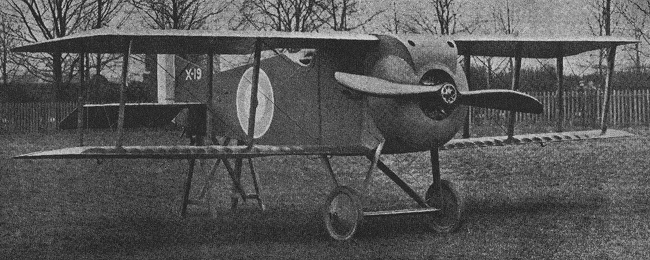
left=456, top=89, right=544, bottom=114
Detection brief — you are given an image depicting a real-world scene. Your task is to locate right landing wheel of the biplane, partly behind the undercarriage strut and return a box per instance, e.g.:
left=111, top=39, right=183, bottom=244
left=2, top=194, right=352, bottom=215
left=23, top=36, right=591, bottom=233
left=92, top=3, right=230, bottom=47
left=425, top=180, right=464, bottom=233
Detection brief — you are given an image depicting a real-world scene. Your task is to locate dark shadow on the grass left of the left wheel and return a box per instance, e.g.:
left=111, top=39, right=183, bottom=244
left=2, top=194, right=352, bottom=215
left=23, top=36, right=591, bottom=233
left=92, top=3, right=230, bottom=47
left=54, top=209, right=327, bottom=254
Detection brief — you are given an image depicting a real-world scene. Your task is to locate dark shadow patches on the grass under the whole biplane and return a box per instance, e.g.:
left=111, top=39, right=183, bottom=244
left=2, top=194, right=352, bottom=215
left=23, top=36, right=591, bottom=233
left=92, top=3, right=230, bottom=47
left=52, top=194, right=605, bottom=254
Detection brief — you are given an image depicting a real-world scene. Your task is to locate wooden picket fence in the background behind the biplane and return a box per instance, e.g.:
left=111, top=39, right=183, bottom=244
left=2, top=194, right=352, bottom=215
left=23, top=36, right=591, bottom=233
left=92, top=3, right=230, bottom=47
left=0, top=89, right=650, bottom=133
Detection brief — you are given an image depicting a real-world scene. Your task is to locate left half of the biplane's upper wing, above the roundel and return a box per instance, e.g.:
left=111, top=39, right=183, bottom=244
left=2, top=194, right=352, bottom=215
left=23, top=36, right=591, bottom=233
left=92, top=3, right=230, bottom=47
left=13, top=28, right=379, bottom=54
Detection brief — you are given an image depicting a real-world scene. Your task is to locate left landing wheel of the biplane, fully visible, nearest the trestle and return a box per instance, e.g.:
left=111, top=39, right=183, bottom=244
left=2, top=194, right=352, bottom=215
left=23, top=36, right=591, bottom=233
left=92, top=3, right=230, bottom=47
left=323, top=186, right=363, bottom=240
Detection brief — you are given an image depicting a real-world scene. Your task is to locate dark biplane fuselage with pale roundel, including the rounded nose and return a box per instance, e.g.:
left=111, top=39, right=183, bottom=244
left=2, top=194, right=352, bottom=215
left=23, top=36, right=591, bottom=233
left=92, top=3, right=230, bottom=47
left=212, top=36, right=467, bottom=153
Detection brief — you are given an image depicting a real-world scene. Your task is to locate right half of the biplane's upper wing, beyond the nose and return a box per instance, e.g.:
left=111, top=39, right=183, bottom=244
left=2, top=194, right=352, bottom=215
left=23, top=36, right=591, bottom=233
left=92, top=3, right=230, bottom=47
left=454, top=36, right=639, bottom=58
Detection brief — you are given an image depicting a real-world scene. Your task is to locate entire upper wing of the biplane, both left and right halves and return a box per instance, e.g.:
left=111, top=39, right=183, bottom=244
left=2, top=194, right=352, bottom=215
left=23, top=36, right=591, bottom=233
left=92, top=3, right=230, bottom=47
left=13, top=28, right=638, bottom=58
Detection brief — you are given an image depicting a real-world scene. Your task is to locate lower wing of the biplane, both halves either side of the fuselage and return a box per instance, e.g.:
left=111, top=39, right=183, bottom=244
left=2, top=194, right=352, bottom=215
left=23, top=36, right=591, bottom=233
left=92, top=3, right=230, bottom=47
left=14, top=129, right=634, bottom=159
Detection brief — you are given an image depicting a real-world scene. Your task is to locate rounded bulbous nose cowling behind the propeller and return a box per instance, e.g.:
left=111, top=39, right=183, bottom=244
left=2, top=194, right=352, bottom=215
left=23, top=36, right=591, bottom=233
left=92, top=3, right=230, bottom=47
left=366, top=36, right=467, bottom=153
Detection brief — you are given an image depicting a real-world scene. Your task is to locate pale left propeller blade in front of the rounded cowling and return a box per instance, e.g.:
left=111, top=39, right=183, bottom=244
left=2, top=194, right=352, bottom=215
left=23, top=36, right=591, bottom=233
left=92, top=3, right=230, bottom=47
left=334, top=72, right=442, bottom=97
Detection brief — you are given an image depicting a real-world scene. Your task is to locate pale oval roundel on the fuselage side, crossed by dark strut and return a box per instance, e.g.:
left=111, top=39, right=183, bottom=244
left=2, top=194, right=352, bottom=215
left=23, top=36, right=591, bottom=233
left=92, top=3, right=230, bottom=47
left=236, top=67, right=275, bottom=138
